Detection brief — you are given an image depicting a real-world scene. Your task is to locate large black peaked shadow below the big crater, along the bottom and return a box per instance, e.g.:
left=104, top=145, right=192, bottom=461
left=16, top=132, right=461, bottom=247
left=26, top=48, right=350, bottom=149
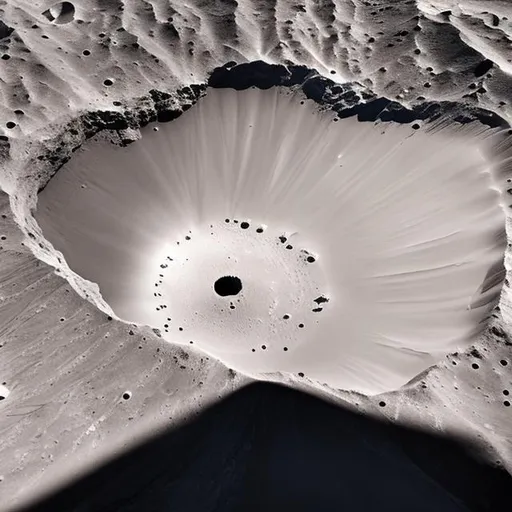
left=16, top=383, right=512, bottom=512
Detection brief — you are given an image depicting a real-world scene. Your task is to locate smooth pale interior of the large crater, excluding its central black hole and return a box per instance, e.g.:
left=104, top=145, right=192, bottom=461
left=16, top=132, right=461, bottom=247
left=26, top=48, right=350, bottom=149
left=36, top=88, right=505, bottom=394
